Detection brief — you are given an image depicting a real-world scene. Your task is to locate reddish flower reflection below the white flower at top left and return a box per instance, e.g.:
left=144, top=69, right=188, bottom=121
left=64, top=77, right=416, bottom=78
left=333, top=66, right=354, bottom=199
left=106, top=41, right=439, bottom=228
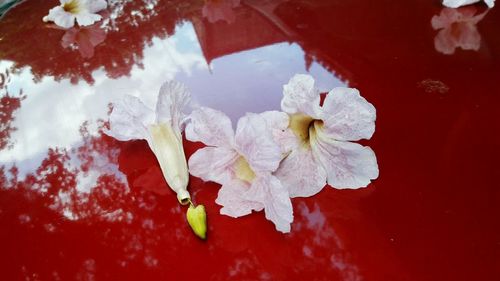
left=61, top=24, right=106, bottom=58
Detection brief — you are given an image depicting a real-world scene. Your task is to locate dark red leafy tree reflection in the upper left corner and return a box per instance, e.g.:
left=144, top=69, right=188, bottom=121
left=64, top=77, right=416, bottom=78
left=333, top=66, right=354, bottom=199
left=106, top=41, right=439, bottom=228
left=0, top=0, right=179, bottom=83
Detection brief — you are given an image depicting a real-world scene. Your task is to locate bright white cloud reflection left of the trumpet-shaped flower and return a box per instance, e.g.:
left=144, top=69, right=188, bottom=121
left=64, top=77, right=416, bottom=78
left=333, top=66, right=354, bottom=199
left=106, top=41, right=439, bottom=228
left=0, top=24, right=206, bottom=174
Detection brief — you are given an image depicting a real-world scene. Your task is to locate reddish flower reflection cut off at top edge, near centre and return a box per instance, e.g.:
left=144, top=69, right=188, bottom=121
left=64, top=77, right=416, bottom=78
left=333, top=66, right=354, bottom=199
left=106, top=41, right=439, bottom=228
left=202, top=0, right=240, bottom=23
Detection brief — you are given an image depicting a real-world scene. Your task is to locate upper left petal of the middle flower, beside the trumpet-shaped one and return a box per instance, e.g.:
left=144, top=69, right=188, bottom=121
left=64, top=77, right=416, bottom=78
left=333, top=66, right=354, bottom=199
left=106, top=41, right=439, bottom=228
left=186, top=107, right=234, bottom=147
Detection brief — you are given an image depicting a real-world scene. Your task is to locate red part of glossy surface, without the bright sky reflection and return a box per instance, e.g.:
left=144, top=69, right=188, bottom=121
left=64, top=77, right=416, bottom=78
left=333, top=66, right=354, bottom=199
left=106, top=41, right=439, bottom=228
left=0, top=0, right=500, bottom=280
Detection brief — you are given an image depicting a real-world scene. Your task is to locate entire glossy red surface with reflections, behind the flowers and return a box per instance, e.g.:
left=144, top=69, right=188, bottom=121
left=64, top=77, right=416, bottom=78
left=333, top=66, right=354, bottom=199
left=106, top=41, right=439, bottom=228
left=0, top=0, right=500, bottom=280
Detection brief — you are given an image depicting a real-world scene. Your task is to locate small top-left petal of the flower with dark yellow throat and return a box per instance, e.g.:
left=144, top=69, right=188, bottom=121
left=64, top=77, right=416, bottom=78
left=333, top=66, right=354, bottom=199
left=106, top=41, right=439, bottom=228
left=281, top=74, right=320, bottom=119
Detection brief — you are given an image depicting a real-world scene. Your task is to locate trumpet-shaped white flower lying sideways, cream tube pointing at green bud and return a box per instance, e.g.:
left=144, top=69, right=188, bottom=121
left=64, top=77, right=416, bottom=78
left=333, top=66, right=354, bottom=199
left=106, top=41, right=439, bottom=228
left=106, top=81, right=191, bottom=204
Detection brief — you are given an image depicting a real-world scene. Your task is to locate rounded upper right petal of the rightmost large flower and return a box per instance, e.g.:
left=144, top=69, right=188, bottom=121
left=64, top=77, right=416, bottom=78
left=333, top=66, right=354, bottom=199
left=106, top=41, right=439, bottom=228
left=321, top=88, right=377, bottom=141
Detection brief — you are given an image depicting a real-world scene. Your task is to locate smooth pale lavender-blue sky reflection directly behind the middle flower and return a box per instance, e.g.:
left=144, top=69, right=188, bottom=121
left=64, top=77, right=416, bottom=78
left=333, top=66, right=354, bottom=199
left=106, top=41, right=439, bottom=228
left=177, top=43, right=344, bottom=122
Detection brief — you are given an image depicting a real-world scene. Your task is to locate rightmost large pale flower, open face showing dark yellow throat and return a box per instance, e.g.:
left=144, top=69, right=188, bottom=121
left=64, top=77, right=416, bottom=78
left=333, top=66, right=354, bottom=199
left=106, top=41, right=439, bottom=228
left=275, top=74, right=379, bottom=197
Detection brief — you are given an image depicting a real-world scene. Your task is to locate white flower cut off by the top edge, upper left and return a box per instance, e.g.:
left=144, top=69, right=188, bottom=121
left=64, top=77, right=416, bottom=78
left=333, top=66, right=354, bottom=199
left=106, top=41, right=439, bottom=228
left=43, top=0, right=107, bottom=28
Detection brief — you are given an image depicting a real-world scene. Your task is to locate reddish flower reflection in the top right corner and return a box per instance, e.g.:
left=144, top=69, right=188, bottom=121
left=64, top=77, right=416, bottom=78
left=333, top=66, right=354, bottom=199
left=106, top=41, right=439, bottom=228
left=431, top=6, right=488, bottom=55
